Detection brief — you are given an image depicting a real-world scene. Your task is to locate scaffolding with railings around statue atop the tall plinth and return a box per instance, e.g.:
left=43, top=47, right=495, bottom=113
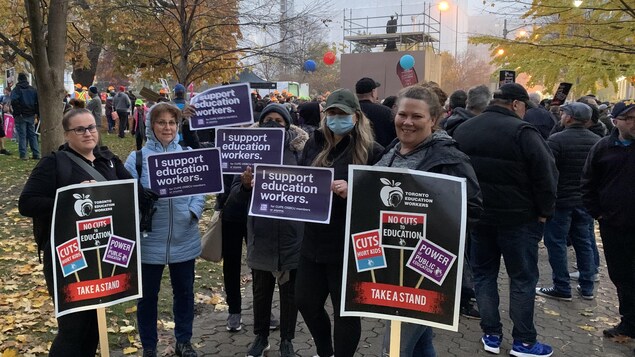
left=343, top=3, right=441, bottom=54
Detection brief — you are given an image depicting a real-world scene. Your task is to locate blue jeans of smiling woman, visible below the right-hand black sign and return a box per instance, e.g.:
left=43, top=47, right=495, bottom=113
left=382, top=321, right=437, bottom=357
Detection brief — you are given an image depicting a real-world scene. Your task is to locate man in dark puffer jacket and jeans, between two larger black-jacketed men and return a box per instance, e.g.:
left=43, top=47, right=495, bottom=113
left=536, top=102, right=600, bottom=301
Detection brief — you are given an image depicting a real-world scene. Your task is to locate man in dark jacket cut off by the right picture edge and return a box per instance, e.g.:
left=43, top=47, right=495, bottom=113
left=581, top=99, right=635, bottom=337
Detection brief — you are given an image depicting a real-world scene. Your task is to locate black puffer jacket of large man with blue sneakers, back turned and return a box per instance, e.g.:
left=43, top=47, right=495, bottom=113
left=454, top=105, right=558, bottom=225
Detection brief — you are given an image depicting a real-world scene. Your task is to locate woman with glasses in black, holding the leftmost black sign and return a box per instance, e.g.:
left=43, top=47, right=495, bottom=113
left=19, top=109, right=130, bottom=357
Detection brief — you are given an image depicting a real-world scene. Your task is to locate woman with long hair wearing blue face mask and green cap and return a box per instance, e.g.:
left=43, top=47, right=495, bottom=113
left=295, top=89, right=383, bottom=357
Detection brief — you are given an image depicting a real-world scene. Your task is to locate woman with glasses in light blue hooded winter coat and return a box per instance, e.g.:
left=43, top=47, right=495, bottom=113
left=125, top=103, right=205, bottom=357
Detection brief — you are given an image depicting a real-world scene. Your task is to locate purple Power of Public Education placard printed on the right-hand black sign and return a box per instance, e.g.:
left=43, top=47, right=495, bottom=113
left=406, top=239, right=456, bottom=285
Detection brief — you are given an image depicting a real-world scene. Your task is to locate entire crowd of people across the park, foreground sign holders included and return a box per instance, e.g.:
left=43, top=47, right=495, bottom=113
left=11, top=70, right=635, bottom=357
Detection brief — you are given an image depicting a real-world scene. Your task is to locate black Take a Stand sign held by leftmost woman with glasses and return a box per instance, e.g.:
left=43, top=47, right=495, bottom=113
left=50, top=180, right=142, bottom=317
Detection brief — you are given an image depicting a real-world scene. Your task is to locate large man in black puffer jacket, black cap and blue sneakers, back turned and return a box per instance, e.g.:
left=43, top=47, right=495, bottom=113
left=454, top=83, right=558, bottom=356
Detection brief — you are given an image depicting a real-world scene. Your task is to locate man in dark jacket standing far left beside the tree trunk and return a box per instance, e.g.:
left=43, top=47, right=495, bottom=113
left=11, top=73, right=40, bottom=160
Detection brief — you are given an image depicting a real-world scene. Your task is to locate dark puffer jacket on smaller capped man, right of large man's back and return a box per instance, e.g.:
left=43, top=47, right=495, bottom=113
left=547, top=124, right=600, bottom=208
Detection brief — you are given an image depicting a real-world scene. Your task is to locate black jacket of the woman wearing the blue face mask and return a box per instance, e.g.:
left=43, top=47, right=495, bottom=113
left=299, top=129, right=383, bottom=264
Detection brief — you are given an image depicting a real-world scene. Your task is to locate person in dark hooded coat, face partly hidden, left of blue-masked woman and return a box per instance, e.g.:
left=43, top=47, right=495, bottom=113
left=230, top=103, right=309, bottom=357
